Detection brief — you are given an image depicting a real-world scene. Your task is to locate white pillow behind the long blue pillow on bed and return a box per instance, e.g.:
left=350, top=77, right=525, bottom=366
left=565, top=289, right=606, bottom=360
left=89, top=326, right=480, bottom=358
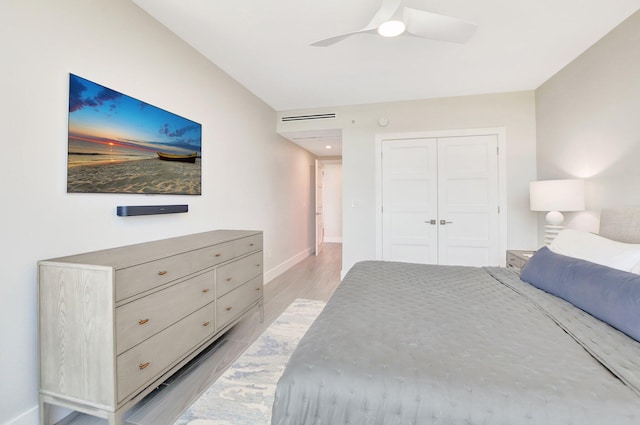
left=549, top=229, right=640, bottom=274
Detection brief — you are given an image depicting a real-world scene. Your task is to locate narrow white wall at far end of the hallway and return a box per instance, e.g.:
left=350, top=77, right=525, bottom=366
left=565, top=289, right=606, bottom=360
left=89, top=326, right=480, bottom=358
left=322, top=160, right=342, bottom=243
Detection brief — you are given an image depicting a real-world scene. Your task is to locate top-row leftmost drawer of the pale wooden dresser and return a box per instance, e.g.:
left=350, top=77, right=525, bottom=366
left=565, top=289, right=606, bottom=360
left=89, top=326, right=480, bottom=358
left=115, top=253, right=191, bottom=302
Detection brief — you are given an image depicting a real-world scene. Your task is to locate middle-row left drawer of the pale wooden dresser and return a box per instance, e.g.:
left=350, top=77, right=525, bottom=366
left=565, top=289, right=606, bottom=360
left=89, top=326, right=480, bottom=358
left=116, top=271, right=215, bottom=354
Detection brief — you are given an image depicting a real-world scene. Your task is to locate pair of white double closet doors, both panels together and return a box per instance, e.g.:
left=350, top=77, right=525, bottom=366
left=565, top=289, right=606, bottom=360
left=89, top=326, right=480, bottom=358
left=381, top=135, right=500, bottom=266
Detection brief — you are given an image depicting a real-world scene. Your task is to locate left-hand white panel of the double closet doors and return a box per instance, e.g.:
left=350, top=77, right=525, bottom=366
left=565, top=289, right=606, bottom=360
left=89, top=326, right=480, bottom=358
left=382, top=139, right=438, bottom=264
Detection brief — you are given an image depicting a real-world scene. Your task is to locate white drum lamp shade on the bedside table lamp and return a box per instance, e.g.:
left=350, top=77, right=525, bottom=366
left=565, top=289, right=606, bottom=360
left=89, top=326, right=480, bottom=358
left=529, top=179, right=584, bottom=211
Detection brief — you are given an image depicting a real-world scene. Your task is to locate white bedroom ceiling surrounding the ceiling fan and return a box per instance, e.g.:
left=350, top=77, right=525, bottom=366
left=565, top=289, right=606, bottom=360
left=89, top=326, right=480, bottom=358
left=133, top=0, right=640, bottom=156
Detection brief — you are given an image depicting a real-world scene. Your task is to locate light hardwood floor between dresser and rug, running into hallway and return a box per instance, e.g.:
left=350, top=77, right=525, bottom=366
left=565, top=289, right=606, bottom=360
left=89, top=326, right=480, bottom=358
left=118, top=244, right=342, bottom=425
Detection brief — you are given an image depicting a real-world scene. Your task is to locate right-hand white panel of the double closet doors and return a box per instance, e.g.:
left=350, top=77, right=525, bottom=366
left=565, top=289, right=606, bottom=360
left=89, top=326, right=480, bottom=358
left=438, top=135, right=500, bottom=266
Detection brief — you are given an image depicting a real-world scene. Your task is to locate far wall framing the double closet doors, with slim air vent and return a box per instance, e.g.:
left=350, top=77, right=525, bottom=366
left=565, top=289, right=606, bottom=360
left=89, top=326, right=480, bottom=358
left=278, top=91, right=537, bottom=273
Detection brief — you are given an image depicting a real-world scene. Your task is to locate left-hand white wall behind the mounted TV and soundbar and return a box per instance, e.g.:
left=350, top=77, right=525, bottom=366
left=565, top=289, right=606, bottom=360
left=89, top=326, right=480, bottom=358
left=0, top=0, right=314, bottom=425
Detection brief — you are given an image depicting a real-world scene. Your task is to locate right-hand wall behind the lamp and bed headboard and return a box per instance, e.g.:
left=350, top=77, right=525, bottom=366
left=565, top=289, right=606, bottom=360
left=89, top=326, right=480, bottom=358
left=536, top=12, right=640, bottom=237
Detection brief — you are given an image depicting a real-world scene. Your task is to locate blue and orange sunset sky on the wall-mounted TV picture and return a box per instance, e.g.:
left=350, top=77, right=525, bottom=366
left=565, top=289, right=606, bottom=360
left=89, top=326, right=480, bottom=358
left=69, top=74, right=202, bottom=156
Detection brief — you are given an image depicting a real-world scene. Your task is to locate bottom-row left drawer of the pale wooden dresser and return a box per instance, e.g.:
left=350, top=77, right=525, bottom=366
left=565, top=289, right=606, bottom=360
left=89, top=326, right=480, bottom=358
left=117, top=303, right=215, bottom=401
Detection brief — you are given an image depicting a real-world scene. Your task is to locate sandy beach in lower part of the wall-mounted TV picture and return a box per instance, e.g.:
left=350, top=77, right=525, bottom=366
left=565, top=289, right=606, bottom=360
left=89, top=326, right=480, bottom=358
left=67, top=158, right=201, bottom=195
